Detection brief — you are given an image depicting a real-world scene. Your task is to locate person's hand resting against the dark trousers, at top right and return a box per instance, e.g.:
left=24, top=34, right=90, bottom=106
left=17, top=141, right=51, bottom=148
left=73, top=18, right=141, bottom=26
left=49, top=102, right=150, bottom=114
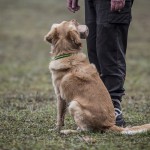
left=111, top=0, right=125, bottom=11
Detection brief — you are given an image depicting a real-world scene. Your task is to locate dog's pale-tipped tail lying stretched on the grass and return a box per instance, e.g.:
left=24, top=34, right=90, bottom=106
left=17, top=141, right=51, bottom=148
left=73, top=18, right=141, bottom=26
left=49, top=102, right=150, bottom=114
left=110, top=124, right=150, bottom=135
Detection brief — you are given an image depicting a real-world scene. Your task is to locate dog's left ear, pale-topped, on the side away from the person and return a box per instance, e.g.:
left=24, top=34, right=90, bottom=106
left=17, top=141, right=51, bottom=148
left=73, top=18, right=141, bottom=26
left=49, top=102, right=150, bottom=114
left=44, top=24, right=58, bottom=44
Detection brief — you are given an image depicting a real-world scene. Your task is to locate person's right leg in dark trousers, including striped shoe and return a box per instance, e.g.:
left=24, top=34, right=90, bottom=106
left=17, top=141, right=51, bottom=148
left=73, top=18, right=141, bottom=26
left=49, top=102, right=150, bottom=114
left=95, top=0, right=131, bottom=126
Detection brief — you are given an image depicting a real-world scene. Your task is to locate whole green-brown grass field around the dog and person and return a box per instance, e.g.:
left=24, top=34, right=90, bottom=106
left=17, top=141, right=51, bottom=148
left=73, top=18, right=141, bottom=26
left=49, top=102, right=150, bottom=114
left=0, top=0, right=150, bottom=150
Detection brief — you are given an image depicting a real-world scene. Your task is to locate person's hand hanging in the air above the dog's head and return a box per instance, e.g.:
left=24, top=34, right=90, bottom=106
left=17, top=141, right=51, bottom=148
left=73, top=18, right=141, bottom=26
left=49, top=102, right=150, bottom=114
left=67, top=0, right=80, bottom=13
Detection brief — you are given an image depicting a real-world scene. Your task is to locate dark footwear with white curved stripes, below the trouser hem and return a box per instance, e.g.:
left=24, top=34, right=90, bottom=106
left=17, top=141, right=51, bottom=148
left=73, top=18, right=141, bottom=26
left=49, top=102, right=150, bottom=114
left=112, top=99, right=125, bottom=127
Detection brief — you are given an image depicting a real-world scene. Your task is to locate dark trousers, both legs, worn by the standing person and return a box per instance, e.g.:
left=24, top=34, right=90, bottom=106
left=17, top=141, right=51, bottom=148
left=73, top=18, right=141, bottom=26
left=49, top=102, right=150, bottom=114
left=85, top=0, right=132, bottom=101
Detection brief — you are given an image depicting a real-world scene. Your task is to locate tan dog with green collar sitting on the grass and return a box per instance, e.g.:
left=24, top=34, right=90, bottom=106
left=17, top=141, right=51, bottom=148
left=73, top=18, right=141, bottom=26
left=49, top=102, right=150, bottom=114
left=45, top=20, right=150, bottom=134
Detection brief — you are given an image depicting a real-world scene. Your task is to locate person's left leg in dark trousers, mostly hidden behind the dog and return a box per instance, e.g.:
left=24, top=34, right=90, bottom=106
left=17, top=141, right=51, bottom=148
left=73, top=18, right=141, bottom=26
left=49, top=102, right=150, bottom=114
left=85, top=0, right=100, bottom=73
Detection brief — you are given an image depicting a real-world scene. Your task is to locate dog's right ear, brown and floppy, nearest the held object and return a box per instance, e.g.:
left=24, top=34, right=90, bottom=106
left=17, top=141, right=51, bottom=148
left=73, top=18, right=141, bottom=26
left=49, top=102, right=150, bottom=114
left=67, top=30, right=82, bottom=47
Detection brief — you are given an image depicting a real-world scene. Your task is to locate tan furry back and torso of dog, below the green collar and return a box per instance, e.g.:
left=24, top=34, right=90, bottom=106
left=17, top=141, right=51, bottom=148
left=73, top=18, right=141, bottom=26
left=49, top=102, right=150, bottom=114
left=50, top=53, right=115, bottom=128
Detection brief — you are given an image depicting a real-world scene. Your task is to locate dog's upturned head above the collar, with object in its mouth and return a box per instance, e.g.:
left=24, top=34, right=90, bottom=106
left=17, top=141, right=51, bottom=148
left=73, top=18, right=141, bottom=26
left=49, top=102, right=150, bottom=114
left=45, top=20, right=88, bottom=55
